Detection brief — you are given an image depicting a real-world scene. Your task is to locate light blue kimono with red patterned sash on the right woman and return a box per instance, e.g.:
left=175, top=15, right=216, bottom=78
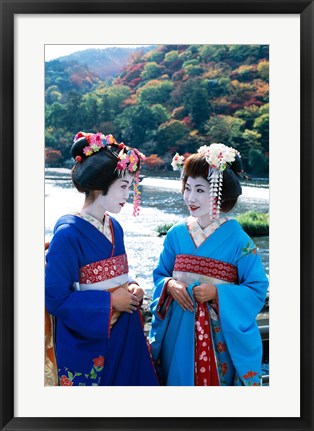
left=149, top=217, right=268, bottom=386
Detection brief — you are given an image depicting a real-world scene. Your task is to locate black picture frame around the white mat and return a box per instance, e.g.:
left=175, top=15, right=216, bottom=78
left=0, top=0, right=314, bottom=431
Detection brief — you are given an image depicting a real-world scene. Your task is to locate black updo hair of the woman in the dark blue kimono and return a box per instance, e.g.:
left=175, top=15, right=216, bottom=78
left=71, top=137, right=140, bottom=195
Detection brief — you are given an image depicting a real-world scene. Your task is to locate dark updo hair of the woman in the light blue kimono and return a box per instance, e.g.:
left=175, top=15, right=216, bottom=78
left=182, top=152, right=243, bottom=213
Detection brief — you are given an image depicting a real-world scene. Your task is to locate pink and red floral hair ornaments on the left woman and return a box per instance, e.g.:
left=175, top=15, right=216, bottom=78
left=74, top=132, right=145, bottom=216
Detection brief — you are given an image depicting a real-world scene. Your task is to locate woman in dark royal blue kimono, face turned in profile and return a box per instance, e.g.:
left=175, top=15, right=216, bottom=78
left=45, top=132, right=158, bottom=386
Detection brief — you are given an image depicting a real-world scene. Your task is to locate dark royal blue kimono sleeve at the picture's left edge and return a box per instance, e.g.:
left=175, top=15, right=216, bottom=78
left=45, top=225, right=111, bottom=339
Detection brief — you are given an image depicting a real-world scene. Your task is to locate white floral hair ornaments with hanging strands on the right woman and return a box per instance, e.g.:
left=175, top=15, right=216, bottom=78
left=171, top=143, right=241, bottom=220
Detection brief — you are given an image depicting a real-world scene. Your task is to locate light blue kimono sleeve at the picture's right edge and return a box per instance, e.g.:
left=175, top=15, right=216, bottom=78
left=216, top=242, right=268, bottom=385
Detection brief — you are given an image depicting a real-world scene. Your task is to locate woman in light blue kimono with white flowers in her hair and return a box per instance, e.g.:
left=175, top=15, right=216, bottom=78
left=149, top=144, right=268, bottom=386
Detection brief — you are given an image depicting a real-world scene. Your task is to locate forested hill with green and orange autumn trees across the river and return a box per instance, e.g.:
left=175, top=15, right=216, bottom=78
left=46, top=45, right=269, bottom=176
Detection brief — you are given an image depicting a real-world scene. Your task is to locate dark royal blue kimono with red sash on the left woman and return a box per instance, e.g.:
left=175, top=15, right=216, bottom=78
left=45, top=215, right=158, bottom=386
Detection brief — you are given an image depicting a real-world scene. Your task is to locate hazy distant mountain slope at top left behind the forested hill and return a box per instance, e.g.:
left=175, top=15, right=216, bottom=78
left=52, top=45, right=154, bottom=79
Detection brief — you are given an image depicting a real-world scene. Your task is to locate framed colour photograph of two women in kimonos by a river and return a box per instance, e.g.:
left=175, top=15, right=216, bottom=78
left=45, top=45, right=270, bottom=386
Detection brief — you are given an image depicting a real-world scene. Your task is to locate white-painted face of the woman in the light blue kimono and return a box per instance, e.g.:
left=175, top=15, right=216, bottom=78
left=183, top=177, right=211, bottom=228
